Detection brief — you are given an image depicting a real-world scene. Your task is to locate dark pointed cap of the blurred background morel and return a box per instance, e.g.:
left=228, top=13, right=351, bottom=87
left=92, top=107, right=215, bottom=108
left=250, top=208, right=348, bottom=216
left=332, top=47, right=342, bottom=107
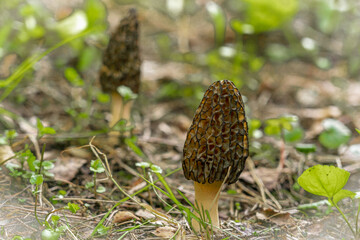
left=100, top=9, right=141, bottom=93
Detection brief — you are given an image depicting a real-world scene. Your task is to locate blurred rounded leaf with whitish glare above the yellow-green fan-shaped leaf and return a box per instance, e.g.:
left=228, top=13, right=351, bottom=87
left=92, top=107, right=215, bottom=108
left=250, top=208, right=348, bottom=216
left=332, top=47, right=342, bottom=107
left=319, top=119, right=351, bottom=149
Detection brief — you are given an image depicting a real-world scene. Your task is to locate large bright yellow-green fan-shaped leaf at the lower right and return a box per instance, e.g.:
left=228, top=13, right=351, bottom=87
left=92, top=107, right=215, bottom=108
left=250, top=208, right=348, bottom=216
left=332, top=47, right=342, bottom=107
left=298, top=165, right=350, bottom=199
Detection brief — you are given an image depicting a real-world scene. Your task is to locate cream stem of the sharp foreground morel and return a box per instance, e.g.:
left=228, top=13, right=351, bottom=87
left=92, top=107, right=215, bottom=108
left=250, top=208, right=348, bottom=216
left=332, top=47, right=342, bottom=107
left=192, top=181, right=222, bottom=232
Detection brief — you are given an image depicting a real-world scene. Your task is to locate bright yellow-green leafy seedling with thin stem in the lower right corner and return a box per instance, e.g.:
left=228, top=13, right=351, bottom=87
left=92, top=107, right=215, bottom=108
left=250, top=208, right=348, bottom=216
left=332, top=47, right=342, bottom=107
left=298, top=165, right=360, bottom=239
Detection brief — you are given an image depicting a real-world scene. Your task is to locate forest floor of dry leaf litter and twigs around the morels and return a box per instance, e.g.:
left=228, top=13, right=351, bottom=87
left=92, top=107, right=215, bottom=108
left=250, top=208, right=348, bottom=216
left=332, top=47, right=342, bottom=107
left=0, top=0, right=360, bottom=239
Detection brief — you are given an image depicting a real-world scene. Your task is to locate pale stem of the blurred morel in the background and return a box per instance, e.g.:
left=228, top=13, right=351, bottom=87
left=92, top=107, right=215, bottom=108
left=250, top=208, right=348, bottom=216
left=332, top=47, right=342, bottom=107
left=109, top=91, right=133, bottom=127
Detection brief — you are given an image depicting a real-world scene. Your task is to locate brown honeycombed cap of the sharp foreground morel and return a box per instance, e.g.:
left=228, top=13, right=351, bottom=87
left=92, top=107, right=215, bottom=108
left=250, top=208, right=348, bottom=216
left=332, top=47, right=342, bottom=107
left=182, top=80, right=249, bottom=184
